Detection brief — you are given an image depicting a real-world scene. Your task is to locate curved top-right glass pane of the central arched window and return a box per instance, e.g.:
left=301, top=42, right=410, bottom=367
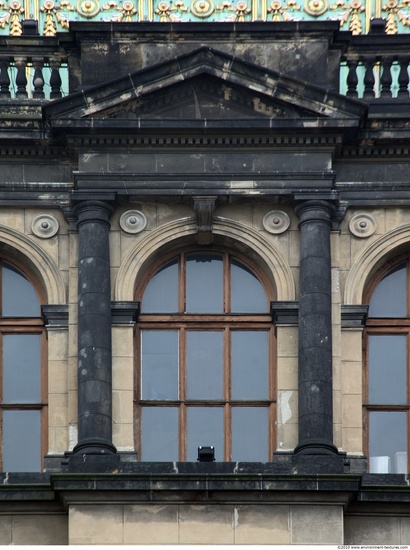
left=231, top=260, right=268, bottom=313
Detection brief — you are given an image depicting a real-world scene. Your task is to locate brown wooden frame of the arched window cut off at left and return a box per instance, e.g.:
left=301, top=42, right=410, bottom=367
left=0, top=257, right=48, bottom=471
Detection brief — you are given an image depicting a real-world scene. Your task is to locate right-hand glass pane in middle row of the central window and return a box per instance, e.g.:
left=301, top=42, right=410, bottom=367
left=231, top=331, right=269, bottom=399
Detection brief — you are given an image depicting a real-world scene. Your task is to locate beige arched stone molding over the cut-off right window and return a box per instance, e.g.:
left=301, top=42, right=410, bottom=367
left=344, top=224, right=410, bottom=305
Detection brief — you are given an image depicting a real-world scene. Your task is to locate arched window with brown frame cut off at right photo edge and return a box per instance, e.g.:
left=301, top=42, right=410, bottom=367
left=365, top=259, right=410, bottom=473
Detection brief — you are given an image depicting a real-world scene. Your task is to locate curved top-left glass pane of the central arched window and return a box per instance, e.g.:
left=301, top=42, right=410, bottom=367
left=141, top=260, right=178, bottom=313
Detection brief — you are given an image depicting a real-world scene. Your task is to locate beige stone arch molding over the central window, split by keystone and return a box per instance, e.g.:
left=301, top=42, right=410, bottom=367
left=114, top=216, right=296, bottom=301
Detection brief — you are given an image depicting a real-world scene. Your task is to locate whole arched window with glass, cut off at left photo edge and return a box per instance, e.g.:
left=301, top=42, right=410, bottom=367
left=0, top=260, right=47, bottom=472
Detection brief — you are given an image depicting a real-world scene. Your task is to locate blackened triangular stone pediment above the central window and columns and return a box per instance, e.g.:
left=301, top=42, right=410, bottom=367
left=44, top=48, right=366, bottom=127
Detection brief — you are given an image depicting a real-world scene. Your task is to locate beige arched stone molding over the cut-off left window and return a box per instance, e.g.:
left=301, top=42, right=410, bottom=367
left=0, top=225, right=66, bottom=304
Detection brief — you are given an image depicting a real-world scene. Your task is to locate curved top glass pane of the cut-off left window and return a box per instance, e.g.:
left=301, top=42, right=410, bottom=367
left=2, top=264, right=40, bottom=317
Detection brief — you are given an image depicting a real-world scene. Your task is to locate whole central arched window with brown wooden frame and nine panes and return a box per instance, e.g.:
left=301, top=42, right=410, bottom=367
left=136, top=250, right=275, bottom=461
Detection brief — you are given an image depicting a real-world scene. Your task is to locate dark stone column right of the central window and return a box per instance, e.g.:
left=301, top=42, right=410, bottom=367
left=295, top=200, right=337, bottom=455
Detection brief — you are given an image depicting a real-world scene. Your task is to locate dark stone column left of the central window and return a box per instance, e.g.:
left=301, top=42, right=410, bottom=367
left=74, top=200, right=116, bottom=454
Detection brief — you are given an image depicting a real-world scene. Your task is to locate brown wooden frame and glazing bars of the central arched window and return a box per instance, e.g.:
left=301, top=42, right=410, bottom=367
left=134, top=247, right=276, bottom=462
